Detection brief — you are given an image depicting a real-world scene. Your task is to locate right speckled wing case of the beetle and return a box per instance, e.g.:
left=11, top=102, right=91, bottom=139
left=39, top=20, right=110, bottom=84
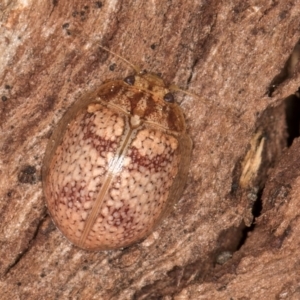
left=85, top=129, right=179, bottom=248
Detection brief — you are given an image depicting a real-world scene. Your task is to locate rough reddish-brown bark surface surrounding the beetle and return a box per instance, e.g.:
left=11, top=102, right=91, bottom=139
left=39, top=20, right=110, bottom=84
left=0, top=0, right=300, bottom=300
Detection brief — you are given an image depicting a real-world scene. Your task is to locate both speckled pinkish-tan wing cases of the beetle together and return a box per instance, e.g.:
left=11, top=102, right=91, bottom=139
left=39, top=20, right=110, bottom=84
left=48, top=104, right=180, bottom=249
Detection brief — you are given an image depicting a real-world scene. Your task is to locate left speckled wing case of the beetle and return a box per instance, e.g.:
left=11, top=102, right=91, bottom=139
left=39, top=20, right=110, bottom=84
left=48, top=105, right=124, bottom=243
